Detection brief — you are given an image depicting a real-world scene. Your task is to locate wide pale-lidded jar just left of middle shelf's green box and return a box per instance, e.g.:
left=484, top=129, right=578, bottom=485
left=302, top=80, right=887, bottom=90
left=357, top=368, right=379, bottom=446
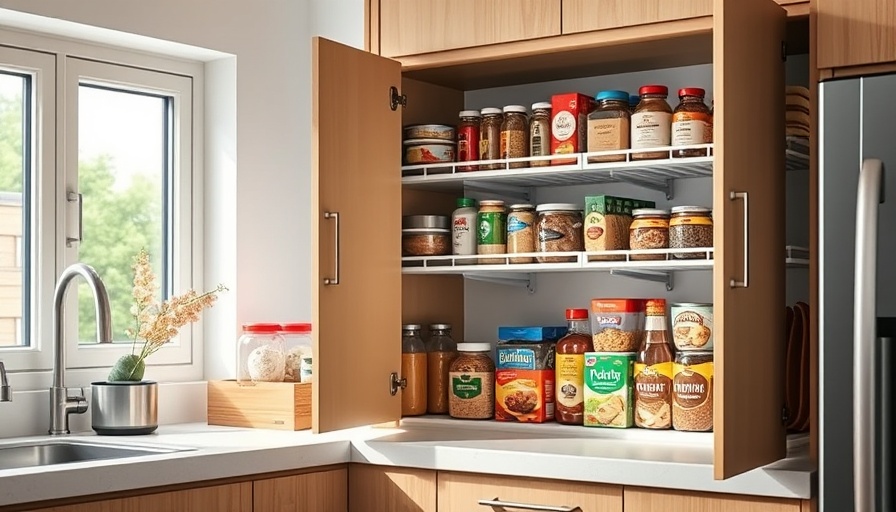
left=535, top=203, right=585, bottom=263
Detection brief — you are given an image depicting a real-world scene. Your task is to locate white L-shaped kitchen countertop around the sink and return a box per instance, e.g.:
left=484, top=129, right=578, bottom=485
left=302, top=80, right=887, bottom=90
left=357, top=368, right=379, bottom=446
left=0, top=418, right=815, bottom=506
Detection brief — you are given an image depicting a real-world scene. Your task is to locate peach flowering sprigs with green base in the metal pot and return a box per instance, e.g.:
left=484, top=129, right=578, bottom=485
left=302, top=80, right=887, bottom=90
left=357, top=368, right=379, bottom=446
left=107, top=249, right=227, bottom=382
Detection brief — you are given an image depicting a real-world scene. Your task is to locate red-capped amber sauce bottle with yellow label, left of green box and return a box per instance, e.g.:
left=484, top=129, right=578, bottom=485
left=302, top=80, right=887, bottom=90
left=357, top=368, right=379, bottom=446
left=554, top=309, right=594, bottom=425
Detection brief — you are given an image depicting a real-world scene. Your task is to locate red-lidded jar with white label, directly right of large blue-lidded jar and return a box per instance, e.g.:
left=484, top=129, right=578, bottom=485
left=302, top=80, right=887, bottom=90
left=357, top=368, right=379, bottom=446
left=631, top=85, right=672, bottom=160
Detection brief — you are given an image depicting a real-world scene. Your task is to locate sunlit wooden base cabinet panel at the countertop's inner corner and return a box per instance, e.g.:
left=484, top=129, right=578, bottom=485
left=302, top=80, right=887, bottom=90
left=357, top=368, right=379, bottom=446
left=348, top=464, right=436, bottom=512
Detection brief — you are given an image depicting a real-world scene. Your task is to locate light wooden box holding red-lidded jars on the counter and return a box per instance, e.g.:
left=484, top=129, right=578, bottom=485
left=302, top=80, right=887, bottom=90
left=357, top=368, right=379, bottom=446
left=208, top=380, right=311, bottom=430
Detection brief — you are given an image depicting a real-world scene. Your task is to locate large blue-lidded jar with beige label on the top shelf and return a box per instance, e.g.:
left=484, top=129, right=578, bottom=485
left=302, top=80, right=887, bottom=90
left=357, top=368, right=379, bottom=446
left=588, top=91, right=631, bottom=163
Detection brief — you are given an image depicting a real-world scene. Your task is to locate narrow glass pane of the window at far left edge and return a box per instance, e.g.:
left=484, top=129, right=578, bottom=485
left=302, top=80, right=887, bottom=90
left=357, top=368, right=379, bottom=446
left=0, top=71, right=31, bottom=347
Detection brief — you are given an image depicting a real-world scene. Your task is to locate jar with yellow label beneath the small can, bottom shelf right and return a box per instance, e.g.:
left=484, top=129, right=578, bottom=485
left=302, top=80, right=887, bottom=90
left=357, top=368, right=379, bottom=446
left=672, top=352, right=713, bottom=432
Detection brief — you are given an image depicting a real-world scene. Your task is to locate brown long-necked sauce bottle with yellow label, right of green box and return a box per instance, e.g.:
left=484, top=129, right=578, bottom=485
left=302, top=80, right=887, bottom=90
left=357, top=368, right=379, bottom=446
left=635, top=299, right=673, bottom=430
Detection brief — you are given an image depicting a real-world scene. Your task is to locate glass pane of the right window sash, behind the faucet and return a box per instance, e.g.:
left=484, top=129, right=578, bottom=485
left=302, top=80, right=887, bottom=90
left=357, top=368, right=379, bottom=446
left=78, top=84, right=172, bottom=343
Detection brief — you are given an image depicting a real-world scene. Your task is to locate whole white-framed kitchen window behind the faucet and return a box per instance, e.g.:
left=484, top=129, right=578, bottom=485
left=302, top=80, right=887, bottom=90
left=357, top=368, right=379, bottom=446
left=0, top=33, right=202, bottom=385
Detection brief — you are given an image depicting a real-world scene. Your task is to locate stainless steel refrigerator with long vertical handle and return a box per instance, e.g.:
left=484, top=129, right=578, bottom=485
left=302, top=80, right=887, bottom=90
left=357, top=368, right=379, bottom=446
left=818, top=75, right=896, bottom=512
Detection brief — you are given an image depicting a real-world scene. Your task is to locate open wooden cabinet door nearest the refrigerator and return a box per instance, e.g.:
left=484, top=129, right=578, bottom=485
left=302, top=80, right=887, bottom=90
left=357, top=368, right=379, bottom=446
left=713, top=0, right=786, bottom=479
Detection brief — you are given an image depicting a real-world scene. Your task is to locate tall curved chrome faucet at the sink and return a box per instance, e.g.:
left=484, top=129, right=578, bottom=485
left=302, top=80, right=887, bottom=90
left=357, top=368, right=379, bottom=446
left=50, top=263, right=112, bottom=436
